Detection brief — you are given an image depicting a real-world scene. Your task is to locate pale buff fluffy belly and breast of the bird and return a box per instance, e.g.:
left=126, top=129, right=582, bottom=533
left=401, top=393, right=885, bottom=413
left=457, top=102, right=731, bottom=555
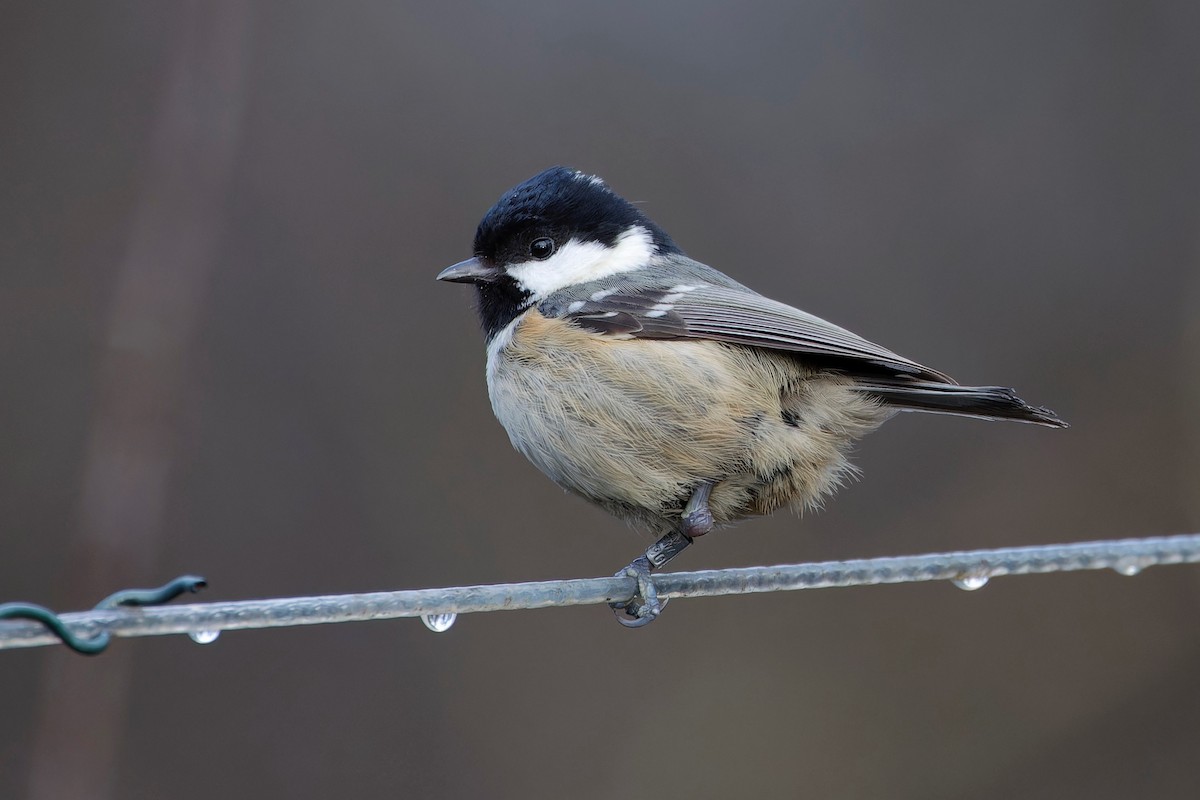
left=487, top=311, right=889, bottom=530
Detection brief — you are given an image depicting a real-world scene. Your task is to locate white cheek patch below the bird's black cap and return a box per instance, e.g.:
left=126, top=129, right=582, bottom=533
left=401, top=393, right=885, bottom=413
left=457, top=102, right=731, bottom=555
left=506, top=225, right=654, bottom=302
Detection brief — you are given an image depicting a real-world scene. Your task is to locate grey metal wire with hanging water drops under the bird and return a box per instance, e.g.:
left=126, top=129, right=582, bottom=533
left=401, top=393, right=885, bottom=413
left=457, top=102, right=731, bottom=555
left=0, top=534, right=1200, bottom=650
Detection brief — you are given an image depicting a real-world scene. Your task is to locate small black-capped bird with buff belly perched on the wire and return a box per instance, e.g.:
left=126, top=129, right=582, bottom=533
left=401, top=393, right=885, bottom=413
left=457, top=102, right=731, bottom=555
left=438, top=167, right=1067, bottom=627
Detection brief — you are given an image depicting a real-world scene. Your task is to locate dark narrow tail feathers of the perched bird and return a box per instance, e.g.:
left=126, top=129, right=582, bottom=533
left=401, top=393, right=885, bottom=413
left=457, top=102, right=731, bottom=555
left=856, top=378, right=1067, bottom=428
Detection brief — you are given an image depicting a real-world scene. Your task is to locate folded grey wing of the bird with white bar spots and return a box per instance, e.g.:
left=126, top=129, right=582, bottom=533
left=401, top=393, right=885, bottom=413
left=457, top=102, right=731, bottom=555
left=540, top=276, right=955, bottom=384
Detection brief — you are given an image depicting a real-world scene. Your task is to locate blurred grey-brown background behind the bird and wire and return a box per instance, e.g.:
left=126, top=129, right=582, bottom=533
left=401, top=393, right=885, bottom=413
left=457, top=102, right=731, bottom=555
left=0, top=0, right=1200, bottom=800
